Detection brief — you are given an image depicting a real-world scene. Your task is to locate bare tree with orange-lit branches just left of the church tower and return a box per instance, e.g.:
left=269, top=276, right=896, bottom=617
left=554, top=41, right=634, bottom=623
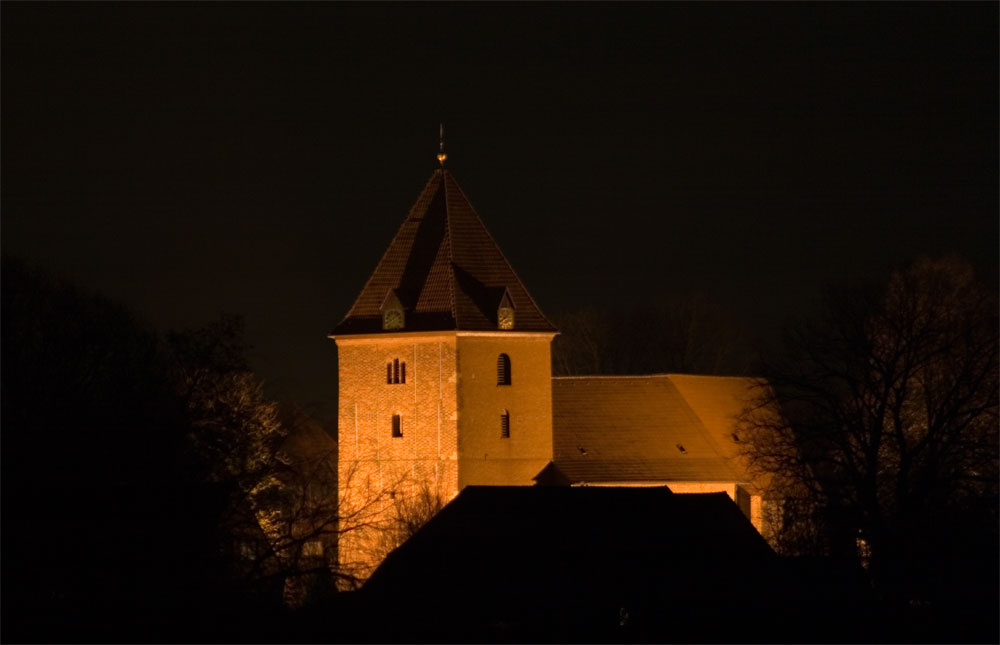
left=170, top=317, right=402, bottom=607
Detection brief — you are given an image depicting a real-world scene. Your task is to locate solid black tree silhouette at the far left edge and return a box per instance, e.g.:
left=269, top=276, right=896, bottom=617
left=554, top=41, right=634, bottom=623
left=2, top=257, right=201, bottom=640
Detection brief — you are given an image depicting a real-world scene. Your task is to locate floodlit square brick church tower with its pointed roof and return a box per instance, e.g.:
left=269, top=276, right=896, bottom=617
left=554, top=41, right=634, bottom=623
left=331, top=166, right=556, bottom=579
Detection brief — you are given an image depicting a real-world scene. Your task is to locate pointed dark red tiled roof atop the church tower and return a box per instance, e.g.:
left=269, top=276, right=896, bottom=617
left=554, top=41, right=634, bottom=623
left=333, top=168, right=556, bottom=335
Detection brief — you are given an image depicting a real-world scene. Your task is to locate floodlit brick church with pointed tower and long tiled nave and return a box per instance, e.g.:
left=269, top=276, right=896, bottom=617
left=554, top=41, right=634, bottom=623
left=330, top=160, right=765, bottom=580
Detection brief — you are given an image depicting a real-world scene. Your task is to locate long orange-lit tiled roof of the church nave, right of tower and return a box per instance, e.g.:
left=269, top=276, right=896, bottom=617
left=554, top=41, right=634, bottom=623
left=552, top=375, right=749, bottom=483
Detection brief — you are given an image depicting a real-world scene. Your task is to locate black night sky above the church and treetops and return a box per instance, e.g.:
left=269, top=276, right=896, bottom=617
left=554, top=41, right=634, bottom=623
left=0, top=2, right=998, bottom=420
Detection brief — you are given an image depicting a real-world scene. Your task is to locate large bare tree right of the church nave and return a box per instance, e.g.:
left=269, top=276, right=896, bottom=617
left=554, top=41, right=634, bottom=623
left=740, top=258, right=998, bottom=593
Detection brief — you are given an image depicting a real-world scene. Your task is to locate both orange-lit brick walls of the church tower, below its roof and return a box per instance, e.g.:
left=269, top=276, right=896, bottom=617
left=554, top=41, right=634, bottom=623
left=336, top=332, right=554, bottom=578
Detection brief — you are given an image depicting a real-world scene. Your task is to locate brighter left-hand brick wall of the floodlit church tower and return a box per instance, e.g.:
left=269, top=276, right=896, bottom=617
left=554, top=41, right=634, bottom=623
left=337, top=334, right=458, bottom=578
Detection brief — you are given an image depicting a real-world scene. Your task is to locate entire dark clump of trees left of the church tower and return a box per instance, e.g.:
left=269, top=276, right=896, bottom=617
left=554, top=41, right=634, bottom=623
left=0, top=257, right=378, bottom=641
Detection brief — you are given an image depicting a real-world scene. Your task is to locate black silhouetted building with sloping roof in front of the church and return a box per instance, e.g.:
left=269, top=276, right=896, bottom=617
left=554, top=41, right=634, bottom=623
left=362, top=486, right=798, bottom=642
